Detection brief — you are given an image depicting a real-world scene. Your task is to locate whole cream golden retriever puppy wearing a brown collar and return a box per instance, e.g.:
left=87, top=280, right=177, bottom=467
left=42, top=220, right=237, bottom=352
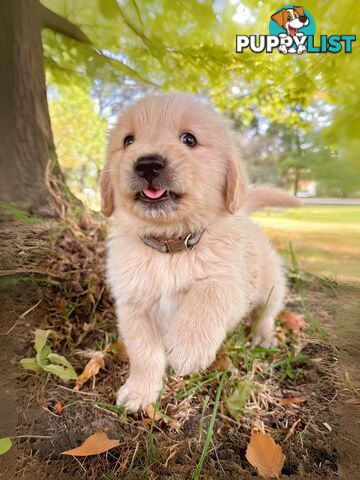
left=100, top=94, right=298, bottom=411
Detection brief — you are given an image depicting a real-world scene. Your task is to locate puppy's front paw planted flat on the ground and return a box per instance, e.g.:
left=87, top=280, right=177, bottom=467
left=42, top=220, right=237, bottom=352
left=116, top=379, right=161, bottom=412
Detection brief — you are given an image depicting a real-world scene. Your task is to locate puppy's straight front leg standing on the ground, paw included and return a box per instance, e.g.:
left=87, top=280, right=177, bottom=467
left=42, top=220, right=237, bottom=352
left=116, top=304, right=166, bottom=412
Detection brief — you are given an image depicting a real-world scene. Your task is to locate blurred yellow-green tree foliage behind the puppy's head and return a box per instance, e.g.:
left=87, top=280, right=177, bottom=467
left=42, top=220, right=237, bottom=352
left=42, top=0, right=360, bottom=206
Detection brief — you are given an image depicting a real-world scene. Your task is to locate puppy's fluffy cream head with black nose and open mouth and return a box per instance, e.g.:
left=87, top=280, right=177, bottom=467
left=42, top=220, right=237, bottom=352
left=100, top=94, right=246, bottom=232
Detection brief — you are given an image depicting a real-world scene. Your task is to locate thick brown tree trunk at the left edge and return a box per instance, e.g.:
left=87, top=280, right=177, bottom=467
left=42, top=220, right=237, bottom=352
left=0, top=0, right=60, bottom=216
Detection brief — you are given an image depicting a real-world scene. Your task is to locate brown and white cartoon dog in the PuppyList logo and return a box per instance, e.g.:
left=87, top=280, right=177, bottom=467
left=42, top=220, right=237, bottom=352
left=271, top=6, right=310, bottom=54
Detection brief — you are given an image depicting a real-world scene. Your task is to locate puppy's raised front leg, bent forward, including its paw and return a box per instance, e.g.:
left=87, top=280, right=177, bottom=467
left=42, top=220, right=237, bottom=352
left=164, top=278, right=242, bottom=375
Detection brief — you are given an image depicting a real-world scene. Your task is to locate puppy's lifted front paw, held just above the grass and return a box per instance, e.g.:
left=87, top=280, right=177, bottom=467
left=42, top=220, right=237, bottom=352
left=166, top=335, right=221, bottom=375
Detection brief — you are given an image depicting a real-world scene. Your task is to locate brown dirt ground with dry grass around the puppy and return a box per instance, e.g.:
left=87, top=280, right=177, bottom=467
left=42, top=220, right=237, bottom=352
left=0, top=212, right=360, bottom=480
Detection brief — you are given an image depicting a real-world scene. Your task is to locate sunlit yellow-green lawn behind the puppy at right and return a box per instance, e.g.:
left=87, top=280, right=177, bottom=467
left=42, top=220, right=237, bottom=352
left=254, top=206, right=360, bottom=283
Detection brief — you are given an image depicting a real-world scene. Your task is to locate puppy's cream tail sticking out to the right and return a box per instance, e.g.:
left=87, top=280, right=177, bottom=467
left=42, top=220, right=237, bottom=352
left=242, top=186, right=302, bottom=215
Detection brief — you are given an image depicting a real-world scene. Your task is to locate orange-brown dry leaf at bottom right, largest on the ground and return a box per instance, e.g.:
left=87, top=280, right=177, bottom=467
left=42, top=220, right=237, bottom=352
left=246, top=429, right=285, bottom=479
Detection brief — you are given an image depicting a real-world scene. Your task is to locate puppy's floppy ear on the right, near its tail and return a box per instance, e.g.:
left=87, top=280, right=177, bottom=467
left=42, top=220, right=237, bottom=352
left=225, top=150, right=247, bottom=214
